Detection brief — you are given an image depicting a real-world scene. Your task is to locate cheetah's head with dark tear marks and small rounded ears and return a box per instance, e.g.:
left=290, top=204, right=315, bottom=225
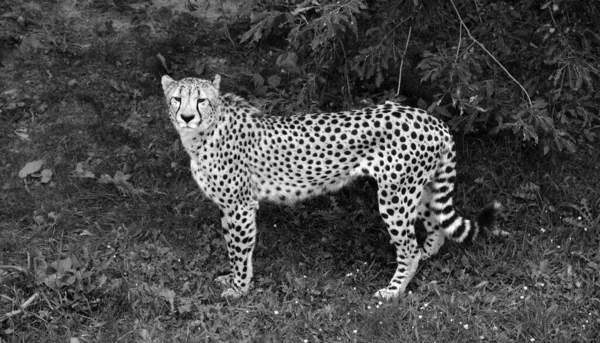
left=161, top=75, right=221, bottom=131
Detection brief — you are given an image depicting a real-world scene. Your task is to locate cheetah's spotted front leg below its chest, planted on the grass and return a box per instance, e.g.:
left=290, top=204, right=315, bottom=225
left=216, top=201, right=258, bottom=298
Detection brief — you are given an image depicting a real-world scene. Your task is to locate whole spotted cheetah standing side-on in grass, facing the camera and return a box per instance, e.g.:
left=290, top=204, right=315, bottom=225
left=161, top=75, right=500, bottom=299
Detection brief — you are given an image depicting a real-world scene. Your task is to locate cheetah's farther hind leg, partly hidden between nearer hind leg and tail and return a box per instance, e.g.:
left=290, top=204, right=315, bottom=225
left=417, top=185, right=446, bottom=259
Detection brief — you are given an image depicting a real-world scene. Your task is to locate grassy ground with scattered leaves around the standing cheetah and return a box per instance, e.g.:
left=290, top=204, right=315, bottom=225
left=0, top=0, right=600, bottom=342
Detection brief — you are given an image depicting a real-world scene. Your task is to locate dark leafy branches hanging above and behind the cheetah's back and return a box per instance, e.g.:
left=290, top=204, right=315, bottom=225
left=240, top=0, right=600, bottom=154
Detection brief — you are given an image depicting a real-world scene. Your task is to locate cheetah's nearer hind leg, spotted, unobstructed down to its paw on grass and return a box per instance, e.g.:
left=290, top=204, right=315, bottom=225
left=375, top=183, right=422, bottom=299
